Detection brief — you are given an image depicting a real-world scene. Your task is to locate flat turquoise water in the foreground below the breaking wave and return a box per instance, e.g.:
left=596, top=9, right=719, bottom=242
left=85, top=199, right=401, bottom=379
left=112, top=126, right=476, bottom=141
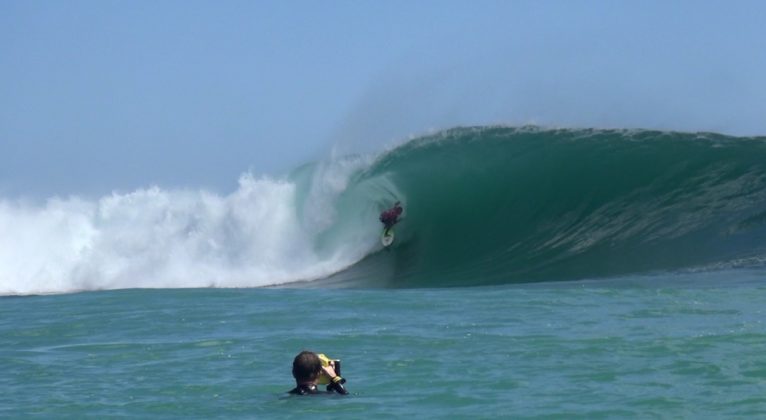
left=0, top=270, right=766, bottom=418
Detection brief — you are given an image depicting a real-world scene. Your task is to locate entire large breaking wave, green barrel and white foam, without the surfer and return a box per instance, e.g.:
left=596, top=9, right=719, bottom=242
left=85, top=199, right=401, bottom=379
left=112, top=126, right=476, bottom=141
left=0, top=127, right=766, bottom=294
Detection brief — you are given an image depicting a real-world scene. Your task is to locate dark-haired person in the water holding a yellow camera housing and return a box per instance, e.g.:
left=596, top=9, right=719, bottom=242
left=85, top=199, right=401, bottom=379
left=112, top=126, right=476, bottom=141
left=290, top=351, right=348, bottom=395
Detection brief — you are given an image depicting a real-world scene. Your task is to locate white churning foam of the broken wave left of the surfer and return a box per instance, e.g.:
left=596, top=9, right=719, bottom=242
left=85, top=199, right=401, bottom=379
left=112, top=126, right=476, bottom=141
left=0, top=165, right=374, bottom=295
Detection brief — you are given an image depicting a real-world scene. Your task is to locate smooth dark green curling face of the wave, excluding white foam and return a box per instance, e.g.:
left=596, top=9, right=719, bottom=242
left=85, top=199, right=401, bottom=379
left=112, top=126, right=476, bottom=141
left=320, top=127, right=766, bottom=287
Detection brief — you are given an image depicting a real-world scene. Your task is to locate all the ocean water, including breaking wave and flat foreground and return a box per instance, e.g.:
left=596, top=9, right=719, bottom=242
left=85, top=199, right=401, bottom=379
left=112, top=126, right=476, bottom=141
left=0, top=127, right=766, bottom=419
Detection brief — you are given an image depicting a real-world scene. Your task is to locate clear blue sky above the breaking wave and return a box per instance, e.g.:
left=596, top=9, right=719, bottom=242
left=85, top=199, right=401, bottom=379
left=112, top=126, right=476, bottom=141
left=0, top=0, right=766, bottom=197
